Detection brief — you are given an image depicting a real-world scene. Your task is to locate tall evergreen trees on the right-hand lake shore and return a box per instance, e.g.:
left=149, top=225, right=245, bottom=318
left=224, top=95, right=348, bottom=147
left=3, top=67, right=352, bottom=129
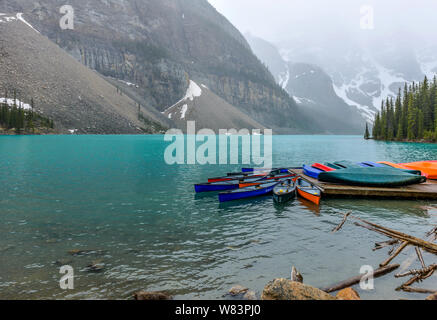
left=372, top=76, right=437, bottom=141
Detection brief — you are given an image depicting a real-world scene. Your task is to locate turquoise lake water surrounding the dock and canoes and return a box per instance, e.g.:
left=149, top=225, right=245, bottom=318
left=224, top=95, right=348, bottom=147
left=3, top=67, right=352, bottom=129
left=0, top=136, right=437, bottom=299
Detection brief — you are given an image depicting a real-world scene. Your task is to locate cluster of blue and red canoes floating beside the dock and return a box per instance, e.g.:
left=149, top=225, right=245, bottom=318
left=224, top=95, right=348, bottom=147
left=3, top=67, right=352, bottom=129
left=194, top=168, right=321, bottom=204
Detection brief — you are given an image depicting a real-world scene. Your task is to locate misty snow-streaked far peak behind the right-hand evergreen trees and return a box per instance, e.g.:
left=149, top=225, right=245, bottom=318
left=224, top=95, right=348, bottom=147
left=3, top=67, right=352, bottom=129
left=281, top=37, right=437, bottom=121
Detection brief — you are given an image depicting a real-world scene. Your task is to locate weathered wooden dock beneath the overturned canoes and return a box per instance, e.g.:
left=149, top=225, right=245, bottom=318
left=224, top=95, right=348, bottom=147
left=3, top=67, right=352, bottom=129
left=290, top=169, right=437, bottom=200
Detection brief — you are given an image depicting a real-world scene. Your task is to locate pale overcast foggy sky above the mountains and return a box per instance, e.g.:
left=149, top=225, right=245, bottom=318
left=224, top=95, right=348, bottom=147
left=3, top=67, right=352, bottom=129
left=209, top=0, right=437, bottom=43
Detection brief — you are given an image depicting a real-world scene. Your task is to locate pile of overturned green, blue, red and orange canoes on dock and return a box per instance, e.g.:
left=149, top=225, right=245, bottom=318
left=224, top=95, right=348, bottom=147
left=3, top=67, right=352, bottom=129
left=303, top=161, right=428, bottom=187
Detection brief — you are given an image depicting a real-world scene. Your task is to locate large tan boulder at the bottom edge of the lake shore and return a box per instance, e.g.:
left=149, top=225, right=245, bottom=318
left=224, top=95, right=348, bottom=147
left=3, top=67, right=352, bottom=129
left=261, top=279, right=336, bottom=300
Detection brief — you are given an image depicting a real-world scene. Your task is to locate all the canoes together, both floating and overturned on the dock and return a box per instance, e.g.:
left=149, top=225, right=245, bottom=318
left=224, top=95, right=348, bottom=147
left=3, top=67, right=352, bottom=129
left=194, top=160, right=437, bottom=205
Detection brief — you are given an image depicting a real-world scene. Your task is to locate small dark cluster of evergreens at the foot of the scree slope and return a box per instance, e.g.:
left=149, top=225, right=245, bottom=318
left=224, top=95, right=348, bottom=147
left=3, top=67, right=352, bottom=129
left=0, top=90, right=54, bottom=133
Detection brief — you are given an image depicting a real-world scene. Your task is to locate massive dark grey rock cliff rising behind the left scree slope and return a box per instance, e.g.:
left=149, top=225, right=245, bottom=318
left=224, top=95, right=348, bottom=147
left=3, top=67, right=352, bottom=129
left=0, top=0, right=304, bottom=131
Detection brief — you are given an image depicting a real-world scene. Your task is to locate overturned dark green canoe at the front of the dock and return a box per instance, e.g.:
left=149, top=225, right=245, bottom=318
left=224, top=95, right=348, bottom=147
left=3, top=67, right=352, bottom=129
left=319, top=167, right=426, bottom=187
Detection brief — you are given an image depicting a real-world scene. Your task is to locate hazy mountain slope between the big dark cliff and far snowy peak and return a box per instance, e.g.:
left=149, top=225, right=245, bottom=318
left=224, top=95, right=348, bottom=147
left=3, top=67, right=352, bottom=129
left=246, top=34, right=364, bottom=134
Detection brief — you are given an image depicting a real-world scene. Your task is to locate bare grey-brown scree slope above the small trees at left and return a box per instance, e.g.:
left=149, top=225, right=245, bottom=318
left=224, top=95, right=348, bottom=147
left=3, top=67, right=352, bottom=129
left=0, top=16, right=167, bottom=134
